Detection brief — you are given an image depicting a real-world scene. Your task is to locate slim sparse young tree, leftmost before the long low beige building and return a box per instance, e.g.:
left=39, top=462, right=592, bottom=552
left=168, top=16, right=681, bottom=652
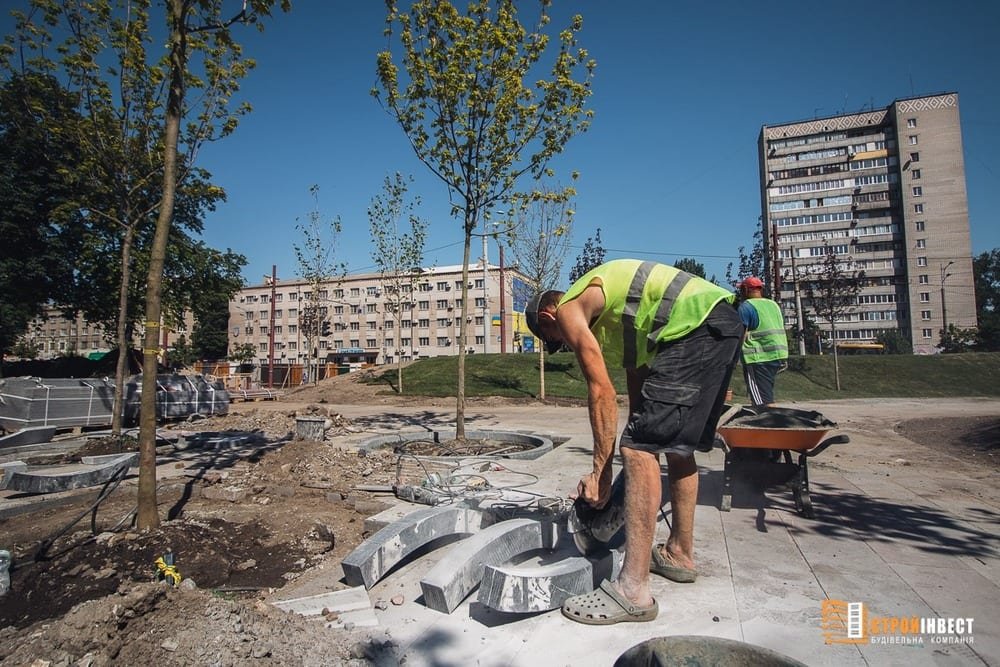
left=293, top=185, right=346, bottom=382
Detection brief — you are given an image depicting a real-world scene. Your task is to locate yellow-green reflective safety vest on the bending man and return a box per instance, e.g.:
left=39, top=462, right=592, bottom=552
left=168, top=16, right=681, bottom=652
left=559, top=259, right=735, bottom=368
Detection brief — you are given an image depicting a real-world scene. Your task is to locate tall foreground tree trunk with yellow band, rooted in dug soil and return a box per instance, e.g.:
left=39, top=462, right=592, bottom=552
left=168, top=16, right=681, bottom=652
left=136, top=0, right=187, bottom=530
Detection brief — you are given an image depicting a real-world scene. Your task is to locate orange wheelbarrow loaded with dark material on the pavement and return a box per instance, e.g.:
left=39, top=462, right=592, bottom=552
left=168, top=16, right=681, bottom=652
left=716, top=407, right=850, bottom=519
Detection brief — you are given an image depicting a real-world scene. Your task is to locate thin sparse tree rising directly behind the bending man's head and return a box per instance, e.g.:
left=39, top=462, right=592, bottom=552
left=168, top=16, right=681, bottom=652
left=508, top=188, right=575, bottom=401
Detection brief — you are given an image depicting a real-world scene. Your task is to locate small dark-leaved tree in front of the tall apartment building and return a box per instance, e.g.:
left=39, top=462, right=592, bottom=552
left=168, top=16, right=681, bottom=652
left=805, top=246, right=865, bottom=391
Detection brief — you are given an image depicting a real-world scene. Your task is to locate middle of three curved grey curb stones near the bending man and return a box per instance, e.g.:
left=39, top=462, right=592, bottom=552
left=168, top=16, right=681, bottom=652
left=420, top=519, right=555, bottom=614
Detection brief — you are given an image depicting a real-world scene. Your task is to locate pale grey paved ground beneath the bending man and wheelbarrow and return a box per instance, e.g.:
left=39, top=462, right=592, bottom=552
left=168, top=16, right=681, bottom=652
left=280, top=399, right=1000, bottom=666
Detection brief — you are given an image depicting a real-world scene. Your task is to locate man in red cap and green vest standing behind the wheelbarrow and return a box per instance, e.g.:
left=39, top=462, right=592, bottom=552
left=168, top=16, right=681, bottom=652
left=736, top=276, right=788, bottom=406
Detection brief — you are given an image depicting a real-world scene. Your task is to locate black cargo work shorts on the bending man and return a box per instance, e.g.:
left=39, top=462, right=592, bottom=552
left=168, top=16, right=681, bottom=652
left=620, top=302, right=743, bottom=456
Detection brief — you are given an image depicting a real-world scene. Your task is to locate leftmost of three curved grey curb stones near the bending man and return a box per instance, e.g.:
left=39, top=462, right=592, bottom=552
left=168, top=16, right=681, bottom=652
left=341, top=507, right=490, bottom=589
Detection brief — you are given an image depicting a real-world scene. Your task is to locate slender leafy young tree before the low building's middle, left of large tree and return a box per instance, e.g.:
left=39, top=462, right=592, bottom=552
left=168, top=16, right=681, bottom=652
left=368, top=172, right=427, bottom=394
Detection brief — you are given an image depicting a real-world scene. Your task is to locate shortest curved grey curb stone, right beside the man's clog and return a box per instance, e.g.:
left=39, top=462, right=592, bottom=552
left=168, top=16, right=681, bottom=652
left=479, top=556, right=594, bottom=614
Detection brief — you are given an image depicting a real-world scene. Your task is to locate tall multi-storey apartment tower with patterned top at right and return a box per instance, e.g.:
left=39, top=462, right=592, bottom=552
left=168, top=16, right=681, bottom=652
left=759, top=93, right=976, bottom=354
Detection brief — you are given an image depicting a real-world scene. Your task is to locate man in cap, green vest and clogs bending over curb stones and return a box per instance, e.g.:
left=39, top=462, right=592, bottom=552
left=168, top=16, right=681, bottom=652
left=525, top=259, right=743, bottom=625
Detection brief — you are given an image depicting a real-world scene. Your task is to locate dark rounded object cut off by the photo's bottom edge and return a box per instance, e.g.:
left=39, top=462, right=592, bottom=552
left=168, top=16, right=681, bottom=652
left=615, top=635, right=806, bottom=667
